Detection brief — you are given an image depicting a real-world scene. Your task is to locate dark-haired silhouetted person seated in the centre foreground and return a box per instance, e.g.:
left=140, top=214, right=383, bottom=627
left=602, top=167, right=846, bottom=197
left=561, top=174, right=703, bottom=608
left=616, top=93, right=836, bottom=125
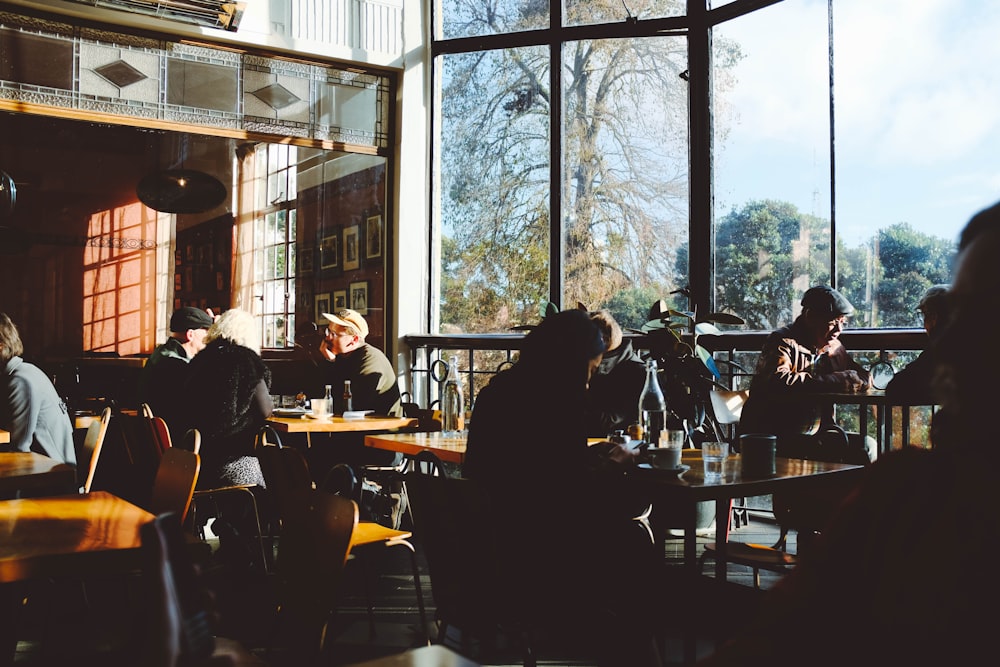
left=462, top=310, right=670, bottom=665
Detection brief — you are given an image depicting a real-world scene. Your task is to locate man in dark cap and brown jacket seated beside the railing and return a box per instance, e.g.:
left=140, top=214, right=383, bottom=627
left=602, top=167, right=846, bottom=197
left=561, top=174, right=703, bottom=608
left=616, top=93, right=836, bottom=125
left=739, top=285, right=878, bottom=463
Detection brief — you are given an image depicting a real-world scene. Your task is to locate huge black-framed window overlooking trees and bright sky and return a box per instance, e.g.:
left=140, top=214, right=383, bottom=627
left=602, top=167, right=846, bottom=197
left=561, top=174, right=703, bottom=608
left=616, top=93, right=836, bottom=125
left=433, top=0, right=1000, bottom=332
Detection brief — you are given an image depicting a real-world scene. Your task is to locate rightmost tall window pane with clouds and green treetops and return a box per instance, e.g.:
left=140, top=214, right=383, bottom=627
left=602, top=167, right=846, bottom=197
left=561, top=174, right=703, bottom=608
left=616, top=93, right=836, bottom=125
left=834, top=0, right=988, bottom=327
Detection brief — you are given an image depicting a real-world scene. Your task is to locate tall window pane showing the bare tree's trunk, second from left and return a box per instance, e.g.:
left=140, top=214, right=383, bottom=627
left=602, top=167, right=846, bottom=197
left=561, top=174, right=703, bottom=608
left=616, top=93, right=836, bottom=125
left=563, top=37, right=688, bottom=328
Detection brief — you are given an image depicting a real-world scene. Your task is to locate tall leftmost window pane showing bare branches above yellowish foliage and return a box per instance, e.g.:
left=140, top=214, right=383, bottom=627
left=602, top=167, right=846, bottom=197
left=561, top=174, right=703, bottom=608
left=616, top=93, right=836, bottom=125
left=438, top=47, right=551, bottom=332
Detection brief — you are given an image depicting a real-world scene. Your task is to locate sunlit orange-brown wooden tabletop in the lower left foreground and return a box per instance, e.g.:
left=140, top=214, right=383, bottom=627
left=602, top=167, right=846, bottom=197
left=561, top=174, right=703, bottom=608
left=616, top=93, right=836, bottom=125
left=0, top=491, right=154, bottom=583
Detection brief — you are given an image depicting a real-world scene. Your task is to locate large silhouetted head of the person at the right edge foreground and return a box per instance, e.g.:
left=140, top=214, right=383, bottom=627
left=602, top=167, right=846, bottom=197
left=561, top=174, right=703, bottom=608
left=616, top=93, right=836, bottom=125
left=933, top=203, right=1000, bottom=445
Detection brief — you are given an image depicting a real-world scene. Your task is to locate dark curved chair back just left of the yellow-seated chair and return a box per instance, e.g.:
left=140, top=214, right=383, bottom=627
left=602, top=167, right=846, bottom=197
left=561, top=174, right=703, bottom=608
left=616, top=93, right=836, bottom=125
left=269, top=488, right=358, bottom=664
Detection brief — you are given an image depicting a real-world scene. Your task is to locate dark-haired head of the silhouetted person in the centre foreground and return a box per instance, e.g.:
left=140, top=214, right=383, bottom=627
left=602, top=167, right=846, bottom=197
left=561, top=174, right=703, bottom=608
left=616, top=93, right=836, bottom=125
left=517, top=310, right=607, bottom=389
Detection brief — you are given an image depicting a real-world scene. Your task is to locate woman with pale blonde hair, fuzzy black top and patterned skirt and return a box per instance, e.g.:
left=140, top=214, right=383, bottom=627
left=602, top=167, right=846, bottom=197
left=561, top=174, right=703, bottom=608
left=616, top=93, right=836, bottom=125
left=184, top=308, right=274, bottom=568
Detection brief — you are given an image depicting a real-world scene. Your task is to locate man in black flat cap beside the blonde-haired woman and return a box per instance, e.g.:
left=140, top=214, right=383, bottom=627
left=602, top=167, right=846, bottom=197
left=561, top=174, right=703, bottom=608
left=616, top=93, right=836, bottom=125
left=139, top=306, right=213, bottom=440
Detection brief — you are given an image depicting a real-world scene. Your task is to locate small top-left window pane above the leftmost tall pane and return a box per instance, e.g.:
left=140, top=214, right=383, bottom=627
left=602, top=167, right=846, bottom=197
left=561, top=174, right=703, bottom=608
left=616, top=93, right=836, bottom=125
left=434, top=0, right=559, bottom=39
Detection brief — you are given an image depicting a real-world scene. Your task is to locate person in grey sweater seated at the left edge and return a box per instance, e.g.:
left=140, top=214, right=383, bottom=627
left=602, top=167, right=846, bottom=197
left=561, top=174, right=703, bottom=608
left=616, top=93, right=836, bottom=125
left=0, top=313, right=76, bottom=466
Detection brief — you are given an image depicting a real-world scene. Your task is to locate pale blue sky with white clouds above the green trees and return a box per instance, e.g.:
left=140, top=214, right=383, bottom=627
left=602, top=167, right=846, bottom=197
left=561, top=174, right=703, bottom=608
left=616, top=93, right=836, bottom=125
left=716, top=0, right=1000, bottom=247
